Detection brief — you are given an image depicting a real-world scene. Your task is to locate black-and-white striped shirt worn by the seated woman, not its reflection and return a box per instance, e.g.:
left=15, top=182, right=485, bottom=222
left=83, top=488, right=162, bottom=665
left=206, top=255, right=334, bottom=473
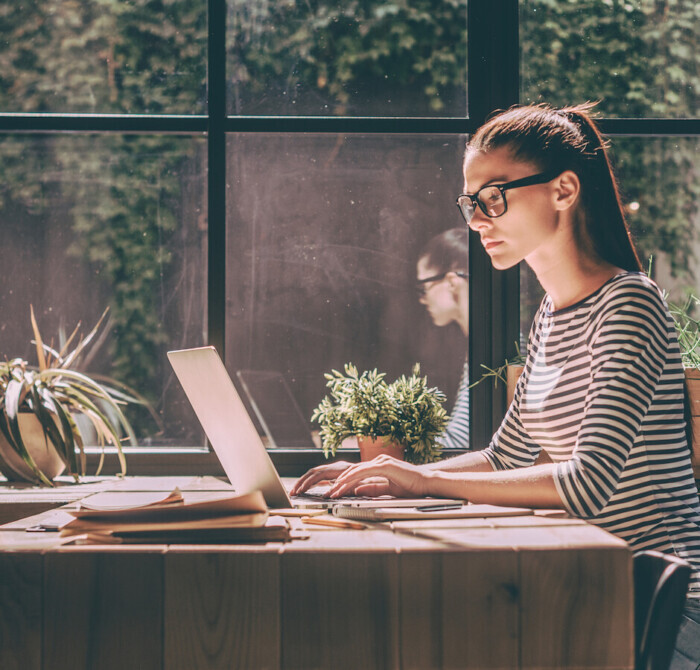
left=484, top=272, right=700, bottom=597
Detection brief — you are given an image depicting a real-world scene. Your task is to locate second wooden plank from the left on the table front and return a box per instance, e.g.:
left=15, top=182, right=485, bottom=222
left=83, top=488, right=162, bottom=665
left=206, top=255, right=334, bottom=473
left=43, top=550, right=163, bottom=670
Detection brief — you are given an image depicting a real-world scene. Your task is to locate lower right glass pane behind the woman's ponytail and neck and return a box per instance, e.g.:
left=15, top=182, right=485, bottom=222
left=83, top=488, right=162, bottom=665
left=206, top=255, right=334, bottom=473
left=520, top=137, right=700, bottom=337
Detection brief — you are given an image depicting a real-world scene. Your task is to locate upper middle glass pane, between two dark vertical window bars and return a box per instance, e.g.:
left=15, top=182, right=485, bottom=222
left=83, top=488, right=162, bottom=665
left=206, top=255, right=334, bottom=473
left=227, top=0, right=467, bottom=117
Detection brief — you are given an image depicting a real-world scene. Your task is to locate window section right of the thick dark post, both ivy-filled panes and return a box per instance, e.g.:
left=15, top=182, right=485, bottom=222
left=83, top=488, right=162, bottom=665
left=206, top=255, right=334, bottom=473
left=520, top=0, right=700, bottom=334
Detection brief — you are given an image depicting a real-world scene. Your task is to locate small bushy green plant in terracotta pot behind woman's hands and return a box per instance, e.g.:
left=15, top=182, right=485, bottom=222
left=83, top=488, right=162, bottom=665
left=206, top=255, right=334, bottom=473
left=311, top=363, right=449, bottom=463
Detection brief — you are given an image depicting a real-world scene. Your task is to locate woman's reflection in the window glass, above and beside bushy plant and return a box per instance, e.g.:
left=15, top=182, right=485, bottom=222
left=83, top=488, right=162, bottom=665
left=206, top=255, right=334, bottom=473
left=416, top=228, right=469, bottom=449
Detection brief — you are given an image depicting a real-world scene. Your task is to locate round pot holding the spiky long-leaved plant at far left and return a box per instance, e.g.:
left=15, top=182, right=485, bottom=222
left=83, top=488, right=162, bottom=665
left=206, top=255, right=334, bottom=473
left=0, top=412, right=66, bottom=482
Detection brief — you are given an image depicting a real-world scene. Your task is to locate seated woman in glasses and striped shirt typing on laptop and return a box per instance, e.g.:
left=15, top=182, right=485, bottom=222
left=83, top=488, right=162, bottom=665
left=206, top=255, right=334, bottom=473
left=296, top=105, right=700, bottom=668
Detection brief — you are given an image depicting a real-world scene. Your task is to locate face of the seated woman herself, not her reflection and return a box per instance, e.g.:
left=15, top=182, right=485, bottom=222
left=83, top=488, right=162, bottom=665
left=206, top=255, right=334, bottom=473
left=464, top=148, right=558, bottom=270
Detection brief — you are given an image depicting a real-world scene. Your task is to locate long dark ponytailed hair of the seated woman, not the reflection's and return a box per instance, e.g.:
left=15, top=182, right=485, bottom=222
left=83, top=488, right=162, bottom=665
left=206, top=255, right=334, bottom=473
left=465, top=103, right=642, bottom=271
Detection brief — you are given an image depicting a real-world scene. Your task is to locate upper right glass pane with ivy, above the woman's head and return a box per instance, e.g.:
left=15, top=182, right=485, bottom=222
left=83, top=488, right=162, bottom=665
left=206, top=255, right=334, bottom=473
left=520, top=0, right=700, bottom=118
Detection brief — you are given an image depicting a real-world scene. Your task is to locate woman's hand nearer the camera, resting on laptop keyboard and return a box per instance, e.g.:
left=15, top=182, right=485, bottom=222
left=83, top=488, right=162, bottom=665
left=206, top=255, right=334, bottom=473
left=329, top=456, right=432, bottom=498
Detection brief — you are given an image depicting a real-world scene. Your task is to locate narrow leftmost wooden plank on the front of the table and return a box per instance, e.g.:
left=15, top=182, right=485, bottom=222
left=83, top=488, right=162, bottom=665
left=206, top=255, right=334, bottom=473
left=0, top=553, right=43, bottom=670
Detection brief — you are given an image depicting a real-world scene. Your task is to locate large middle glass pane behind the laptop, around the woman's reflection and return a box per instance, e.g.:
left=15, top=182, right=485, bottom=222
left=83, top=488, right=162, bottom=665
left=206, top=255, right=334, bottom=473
left=226, top=134, right=468, bottom=446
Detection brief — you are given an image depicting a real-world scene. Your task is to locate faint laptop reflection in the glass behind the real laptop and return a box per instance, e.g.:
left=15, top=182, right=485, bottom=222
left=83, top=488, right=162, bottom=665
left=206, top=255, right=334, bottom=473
left=236, top=370, right=315, bottom=449
